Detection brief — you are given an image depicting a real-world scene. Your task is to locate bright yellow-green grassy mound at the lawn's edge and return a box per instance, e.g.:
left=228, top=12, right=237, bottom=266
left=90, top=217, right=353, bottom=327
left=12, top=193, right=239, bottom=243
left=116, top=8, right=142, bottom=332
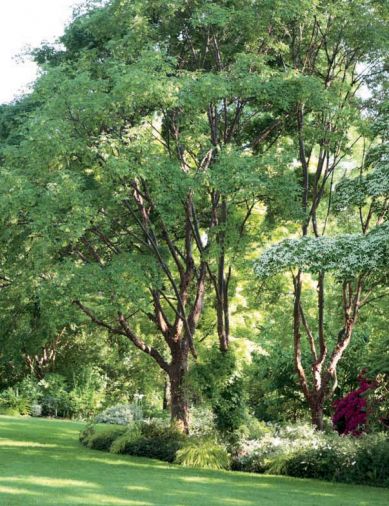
left=175, top=439, right=230, bottom=469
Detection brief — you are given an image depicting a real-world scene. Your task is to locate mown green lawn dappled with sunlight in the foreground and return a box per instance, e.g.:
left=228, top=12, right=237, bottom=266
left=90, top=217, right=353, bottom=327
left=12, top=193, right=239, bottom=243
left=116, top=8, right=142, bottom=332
left=0, top=417, right=389, bottom=506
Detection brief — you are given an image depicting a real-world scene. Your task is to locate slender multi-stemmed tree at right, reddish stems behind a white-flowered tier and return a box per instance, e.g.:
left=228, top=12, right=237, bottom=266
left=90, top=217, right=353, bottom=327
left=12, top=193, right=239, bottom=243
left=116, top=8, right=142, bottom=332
left=257, top=2, right=388, bottom=429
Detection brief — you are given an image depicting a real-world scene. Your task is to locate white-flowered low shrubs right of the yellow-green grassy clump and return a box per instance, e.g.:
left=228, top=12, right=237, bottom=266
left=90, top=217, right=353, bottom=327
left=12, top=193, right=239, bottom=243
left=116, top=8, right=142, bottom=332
left=231, top=425, right=389, bottom=486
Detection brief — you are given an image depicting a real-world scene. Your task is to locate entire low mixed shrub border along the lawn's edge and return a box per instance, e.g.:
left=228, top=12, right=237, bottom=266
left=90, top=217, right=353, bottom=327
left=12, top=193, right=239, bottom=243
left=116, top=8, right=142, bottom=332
left=80, top=419, right=389, bottom=486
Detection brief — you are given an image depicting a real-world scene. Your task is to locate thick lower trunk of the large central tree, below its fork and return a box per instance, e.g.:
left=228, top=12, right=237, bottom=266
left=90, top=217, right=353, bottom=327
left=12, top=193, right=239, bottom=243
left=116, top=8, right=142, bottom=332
left=169, top=343, right=189, bottom=434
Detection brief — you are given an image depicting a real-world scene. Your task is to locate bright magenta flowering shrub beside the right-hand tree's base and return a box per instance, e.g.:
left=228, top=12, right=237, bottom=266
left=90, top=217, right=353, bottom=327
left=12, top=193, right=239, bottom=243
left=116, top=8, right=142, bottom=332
left=332, top=371, right=376, bottom=436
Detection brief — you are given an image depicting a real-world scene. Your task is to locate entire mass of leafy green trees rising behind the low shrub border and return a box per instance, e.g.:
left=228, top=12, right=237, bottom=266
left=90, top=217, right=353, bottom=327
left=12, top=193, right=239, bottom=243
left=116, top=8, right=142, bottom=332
left=0, top=0, right=389, bottom=432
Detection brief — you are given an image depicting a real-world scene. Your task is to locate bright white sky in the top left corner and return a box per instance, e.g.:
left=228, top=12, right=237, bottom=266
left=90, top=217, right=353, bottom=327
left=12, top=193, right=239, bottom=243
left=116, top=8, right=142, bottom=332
left=0, top=0, right=80, bottom=104
